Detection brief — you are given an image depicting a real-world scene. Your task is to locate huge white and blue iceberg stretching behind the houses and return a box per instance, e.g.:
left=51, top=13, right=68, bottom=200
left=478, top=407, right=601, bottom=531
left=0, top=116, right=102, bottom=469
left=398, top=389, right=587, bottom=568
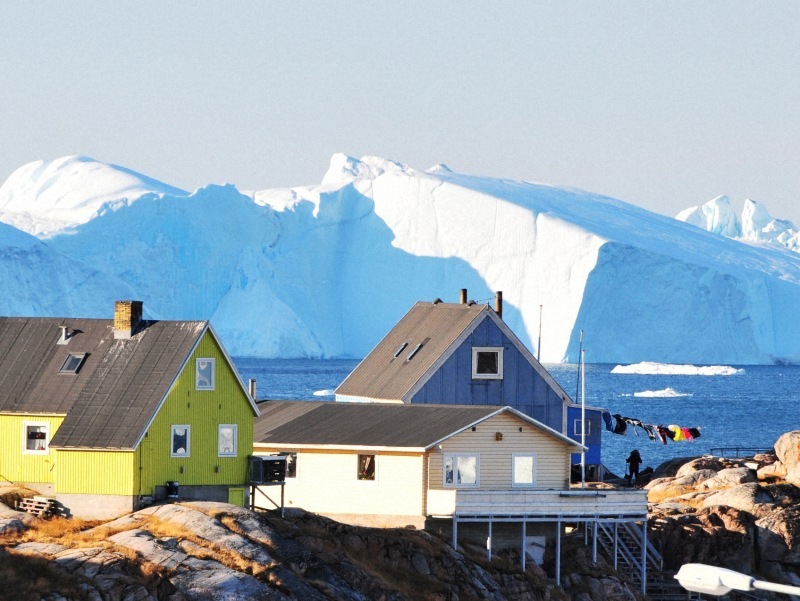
left=0, top=155, right=800, bottom=364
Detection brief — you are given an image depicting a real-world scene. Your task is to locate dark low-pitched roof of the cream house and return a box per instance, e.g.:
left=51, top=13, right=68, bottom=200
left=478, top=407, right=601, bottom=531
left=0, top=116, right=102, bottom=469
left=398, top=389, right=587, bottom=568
left=253, top=401, right=510, bottom=448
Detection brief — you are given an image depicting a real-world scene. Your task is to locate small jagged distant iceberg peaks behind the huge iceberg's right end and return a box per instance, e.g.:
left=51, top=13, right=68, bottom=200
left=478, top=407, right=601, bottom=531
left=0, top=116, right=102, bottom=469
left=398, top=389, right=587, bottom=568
left=675, top=196, right=800, bottom=252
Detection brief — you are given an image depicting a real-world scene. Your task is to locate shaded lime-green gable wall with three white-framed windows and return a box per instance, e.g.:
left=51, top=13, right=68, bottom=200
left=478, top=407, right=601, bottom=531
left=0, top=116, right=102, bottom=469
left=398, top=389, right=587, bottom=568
left=137, top=332, right=254, bottom=495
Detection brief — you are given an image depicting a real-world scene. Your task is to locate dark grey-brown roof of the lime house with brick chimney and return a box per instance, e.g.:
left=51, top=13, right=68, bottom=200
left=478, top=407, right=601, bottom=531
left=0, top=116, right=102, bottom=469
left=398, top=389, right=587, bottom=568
left=0, top=317, right=208, bottom=449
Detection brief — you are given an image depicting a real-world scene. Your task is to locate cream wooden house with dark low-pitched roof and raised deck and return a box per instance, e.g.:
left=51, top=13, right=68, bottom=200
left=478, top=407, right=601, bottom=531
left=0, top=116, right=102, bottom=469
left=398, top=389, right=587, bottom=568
left=253, top=401, right=647, bottom=584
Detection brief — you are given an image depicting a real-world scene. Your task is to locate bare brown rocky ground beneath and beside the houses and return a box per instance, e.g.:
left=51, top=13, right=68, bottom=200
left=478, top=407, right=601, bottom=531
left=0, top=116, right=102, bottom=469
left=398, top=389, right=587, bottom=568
left=0, top=431, right=800, bottom=601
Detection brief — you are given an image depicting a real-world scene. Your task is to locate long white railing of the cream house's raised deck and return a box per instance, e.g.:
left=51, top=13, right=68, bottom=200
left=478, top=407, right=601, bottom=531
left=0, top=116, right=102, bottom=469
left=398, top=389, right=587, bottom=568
left=428, top=489, right=647, bottom=518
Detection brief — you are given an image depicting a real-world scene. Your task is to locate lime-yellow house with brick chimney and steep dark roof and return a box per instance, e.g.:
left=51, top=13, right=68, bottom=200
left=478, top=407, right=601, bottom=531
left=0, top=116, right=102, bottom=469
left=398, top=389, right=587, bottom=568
left=0, top=301, right=258, bottom=519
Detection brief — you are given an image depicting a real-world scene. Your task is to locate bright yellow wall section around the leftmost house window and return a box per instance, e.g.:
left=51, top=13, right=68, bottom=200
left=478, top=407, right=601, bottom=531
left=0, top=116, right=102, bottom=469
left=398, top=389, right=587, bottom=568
left=0, top=414, right=64, bottom=484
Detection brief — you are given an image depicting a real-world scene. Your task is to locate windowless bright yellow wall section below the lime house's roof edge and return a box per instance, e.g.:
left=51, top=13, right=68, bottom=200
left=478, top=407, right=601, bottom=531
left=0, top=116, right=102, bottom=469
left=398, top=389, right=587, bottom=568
left=55, top=449, right=137, bottom=495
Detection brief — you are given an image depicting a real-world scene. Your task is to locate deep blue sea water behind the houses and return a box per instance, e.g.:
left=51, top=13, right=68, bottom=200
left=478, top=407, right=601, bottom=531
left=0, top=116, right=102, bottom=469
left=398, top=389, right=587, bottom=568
left=234, top=358, right=800, bottom=474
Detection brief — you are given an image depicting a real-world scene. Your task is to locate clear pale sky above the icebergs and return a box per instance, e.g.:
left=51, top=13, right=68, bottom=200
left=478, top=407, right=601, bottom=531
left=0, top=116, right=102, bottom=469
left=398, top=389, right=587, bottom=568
left=0, top=0, right=800, bottom=225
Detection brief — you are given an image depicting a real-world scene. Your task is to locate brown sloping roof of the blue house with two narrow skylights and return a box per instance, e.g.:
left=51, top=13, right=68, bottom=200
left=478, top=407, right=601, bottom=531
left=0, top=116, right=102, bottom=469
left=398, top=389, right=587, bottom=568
left=336, top=302, right=492, bottom=400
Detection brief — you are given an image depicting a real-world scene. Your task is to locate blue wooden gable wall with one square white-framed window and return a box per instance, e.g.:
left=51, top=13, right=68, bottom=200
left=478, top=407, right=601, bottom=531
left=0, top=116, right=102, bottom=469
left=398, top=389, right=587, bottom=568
left=410, top=319, right=566, bottom=433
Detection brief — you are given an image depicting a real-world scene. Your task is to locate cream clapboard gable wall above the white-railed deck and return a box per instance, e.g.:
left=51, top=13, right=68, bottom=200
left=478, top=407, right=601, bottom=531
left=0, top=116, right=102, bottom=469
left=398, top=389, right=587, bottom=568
left=428, top=413, right=571, bottom=490
